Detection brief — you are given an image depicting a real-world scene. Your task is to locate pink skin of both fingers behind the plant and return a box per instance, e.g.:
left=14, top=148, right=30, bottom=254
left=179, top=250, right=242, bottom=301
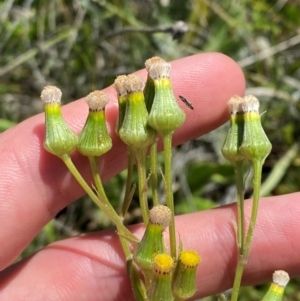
left=0, top=53, right=300, bottom=301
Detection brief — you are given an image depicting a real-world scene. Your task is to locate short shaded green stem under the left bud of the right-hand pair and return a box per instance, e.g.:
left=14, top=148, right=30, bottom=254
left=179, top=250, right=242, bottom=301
left=235, top=161, right=245, bottom=256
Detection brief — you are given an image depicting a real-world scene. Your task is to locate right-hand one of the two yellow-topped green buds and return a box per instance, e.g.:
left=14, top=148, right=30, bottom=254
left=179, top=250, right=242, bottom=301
left=173, top=251, right=201, bottom=300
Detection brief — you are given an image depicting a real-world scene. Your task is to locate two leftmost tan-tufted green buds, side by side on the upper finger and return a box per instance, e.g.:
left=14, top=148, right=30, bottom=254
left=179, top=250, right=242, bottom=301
left=41, top=86, right=112, bottom=157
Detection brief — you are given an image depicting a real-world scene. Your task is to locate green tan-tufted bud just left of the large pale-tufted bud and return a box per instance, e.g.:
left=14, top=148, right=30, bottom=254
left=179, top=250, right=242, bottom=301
left=119, top=74, right=156, bottom=148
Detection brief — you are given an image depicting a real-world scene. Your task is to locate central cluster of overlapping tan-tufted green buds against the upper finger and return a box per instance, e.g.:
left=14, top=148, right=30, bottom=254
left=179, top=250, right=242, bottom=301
left=114, top=57, right=185, bottom=147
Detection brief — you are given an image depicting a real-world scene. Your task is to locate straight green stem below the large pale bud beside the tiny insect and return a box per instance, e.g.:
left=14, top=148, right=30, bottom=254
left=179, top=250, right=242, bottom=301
left=163, top=133, right=176, bottom=258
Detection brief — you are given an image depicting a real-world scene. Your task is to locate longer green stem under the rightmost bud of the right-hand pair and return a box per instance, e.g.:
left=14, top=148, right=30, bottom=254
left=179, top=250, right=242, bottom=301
left=231, top=160, right=263, bottom=301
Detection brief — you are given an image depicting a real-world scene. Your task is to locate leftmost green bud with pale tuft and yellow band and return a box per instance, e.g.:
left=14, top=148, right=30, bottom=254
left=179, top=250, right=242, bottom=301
left=41, top=86, right=78, bottom=157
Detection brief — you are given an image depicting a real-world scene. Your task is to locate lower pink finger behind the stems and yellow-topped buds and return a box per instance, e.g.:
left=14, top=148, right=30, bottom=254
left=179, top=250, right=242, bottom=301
left=0, top=193, right=300, bottom=301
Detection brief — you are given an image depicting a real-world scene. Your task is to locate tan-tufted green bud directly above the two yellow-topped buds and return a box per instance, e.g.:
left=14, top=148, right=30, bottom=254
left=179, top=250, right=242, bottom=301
left=133, top=205, right=172, bottom=270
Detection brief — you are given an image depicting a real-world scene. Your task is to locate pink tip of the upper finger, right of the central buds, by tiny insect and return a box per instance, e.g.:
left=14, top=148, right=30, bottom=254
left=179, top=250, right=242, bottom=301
left=172, top=53, right=245, bottom=144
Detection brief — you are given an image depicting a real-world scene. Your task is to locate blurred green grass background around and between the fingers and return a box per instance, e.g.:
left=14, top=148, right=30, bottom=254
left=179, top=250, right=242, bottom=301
left=0, top=0, right=300, bottom=301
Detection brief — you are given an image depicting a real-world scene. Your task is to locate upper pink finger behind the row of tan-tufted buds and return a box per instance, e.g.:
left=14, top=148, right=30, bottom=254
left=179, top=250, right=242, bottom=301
left=0, top=53, right=244, bottom=270
